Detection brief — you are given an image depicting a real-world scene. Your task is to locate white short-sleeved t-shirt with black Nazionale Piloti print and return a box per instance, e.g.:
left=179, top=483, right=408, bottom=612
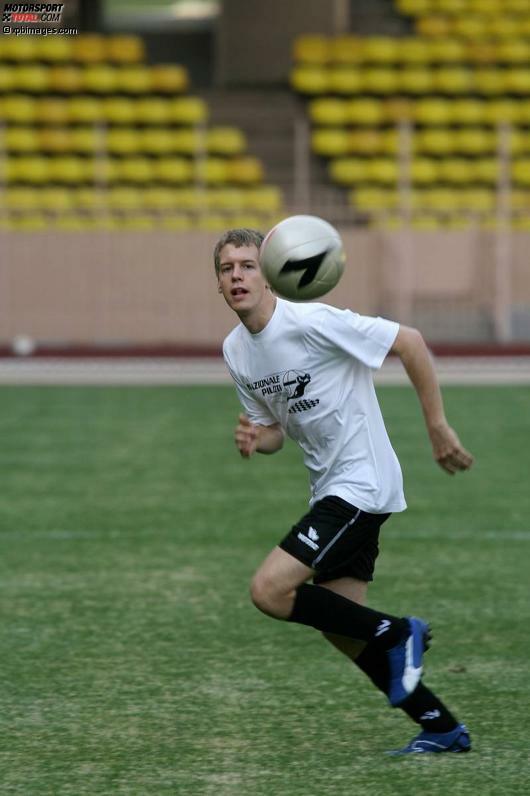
left=223, top=298, right=406, bottom=514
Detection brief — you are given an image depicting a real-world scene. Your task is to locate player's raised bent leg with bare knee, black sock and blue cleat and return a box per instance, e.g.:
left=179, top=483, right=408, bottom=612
left=251, top=547, right=426, bottom=705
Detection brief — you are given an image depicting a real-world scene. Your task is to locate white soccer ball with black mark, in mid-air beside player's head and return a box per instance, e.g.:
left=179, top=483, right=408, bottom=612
left=259, top=216, right=346, bottom=301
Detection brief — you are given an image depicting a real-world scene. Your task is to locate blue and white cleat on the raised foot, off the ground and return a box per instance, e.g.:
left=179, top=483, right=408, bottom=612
left=387, top=616, right=430, bottom=707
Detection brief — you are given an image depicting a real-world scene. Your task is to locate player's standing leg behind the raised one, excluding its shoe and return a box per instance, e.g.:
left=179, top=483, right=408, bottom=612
left=322, top=577, right=458, bottom=733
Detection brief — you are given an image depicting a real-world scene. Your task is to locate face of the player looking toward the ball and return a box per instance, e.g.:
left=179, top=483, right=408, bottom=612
left=218, top=243, right=267, bottom=315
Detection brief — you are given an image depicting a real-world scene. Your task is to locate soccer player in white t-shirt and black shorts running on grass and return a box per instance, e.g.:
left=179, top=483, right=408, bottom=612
left=214, top=229, right=473, bottom=754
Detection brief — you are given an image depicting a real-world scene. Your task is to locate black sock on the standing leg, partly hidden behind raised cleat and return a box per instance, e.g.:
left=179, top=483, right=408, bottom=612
left=355, top=647, right=458, bottom=732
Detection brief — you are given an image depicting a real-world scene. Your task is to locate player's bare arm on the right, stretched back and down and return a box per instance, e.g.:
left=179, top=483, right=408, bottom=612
left=390, top=326, right=473, bottom=475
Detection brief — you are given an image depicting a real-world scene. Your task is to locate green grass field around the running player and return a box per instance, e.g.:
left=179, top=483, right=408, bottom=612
left=0, top=387, right=530, bottom=796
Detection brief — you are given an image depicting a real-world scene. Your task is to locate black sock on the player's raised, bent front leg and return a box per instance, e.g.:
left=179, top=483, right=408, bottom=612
left=289, top=583, right=408, bottom=649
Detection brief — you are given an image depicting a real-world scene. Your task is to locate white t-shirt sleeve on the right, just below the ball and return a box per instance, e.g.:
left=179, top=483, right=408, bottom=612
left=309, top=305, right=399, bottom=369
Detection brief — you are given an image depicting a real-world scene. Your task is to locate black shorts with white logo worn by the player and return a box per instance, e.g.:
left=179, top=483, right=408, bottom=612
left=280, top=495, right=390, bottom=583
